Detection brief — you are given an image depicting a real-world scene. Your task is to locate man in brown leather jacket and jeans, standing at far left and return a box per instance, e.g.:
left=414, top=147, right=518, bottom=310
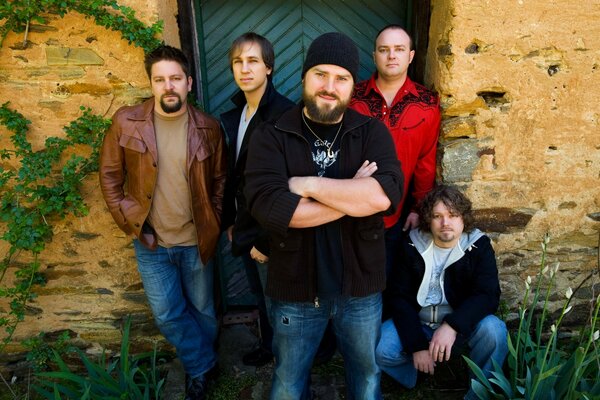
left=100, top=46, right=226, bottom=399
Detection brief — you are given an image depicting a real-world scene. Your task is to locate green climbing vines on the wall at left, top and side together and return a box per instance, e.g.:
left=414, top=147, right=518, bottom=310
left=0, top=0, right=162, bottom=353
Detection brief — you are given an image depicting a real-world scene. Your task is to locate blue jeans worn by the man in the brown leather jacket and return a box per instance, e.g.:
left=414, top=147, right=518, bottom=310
left=133, top=240, right=217, bottom=378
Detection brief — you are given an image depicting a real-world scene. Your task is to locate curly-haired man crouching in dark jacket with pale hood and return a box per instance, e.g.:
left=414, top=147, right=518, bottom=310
left=376, top=185, right=508, bottom=399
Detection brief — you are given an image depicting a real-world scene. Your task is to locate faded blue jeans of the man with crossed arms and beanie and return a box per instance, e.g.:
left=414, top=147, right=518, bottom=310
left=271, top=293, right=381, bottom=400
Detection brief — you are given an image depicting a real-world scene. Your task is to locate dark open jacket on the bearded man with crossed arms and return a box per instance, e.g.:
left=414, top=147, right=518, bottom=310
left=245, top=105, right=403, bottom=301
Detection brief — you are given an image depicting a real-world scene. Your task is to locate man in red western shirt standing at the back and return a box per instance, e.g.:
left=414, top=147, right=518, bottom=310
left=350, top=25, right=440, bottom=276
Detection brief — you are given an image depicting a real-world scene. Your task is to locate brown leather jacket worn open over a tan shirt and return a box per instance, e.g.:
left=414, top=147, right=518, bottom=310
left=100, top=98, right=227, bottom=264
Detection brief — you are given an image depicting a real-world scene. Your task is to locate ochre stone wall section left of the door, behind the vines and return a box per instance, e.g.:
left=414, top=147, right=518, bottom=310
left=0, top=0, right=179, bottom=371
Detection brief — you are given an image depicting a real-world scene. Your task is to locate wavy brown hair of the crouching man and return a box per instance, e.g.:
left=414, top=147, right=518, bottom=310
left=418, top=185, right=475, bottom=233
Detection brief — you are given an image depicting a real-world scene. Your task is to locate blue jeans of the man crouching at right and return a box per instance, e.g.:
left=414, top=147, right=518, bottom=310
left=375, top=315, right=508, bottom=399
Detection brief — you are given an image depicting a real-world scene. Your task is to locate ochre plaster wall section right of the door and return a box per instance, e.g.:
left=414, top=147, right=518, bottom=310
left=427, top=0, right=600, bottom=318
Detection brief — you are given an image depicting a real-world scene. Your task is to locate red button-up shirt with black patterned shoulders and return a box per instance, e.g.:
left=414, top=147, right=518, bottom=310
left=350, top=73, right=440, bottom=228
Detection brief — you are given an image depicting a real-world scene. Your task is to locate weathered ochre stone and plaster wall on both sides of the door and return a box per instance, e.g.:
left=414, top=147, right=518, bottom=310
left=0, top=0, right=600, bottom=376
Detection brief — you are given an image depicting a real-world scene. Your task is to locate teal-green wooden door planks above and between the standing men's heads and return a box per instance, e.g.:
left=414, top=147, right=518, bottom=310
left=196, top=0, right=412, bottom=116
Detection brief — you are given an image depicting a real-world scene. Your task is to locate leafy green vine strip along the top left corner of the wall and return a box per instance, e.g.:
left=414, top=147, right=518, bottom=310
left=0, top=0, right=163, bottom=52
